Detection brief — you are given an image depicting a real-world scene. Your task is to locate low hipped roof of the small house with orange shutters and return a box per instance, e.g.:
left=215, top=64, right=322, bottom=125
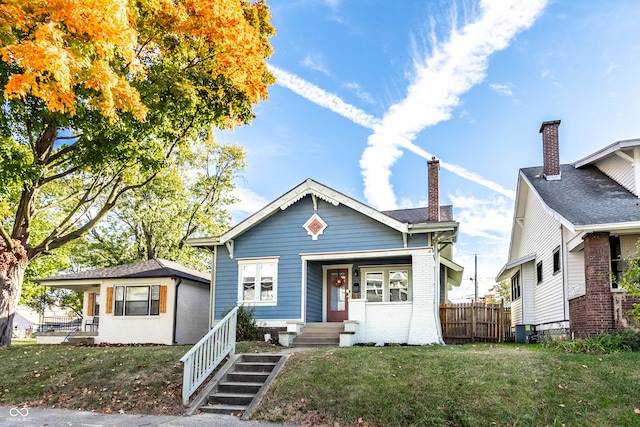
left=36, top=258, right=211, bottom=283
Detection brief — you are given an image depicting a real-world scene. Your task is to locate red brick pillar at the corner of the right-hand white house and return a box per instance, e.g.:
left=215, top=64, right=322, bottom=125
left=569, top=233, right=615, bottom=337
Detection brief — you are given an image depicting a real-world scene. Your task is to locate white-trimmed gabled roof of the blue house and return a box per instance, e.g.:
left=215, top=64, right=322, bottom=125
left=187, top=179, right=458, bottom=247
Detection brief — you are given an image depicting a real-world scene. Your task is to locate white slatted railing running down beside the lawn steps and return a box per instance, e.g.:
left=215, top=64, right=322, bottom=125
left=180, top=307, right=238, bottom=406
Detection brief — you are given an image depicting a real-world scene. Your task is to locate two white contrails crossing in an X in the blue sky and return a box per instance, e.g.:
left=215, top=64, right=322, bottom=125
left=269, top=0, right=547, bottom=209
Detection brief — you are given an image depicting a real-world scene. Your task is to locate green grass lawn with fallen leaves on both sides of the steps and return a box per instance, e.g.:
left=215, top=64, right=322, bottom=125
left=0, top=343, right=640, bottom=427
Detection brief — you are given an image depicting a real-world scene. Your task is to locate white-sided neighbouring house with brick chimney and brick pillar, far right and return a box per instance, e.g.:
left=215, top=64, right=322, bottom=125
left=496, top=120, right=640, bottom=336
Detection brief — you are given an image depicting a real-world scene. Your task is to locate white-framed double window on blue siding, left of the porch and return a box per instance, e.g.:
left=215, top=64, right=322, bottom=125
left=238, top=258, right=278, bottom=305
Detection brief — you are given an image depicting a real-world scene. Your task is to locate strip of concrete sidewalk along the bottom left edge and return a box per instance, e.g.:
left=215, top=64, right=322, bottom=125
left=0, top=406, right=296, bottom=427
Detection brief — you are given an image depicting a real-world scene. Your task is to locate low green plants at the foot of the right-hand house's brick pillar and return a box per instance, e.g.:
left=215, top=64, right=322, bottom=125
left=544, top=330, right=640, bottom=354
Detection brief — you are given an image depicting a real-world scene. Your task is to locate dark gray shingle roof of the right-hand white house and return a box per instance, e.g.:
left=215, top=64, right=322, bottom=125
left=520, top=165, right=640, bottom=226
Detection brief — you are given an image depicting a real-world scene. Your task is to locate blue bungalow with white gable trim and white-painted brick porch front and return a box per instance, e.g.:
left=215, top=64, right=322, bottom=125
left=188, top=158, right=462, bottom=346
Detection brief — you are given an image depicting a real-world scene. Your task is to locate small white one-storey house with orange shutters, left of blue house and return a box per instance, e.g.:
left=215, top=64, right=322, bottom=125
left=37, top=258, right=211, bottom=345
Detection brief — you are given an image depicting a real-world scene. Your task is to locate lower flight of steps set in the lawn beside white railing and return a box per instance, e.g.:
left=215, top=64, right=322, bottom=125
left=195, top=353, right=286, bottom=416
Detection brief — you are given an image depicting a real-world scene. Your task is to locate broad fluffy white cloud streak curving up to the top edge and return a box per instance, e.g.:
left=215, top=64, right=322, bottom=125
left=360, top=0, right=546, bottom=209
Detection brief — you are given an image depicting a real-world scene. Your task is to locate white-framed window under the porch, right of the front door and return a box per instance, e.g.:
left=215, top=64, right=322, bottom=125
left=360, top=266, right=411, bottom=302
